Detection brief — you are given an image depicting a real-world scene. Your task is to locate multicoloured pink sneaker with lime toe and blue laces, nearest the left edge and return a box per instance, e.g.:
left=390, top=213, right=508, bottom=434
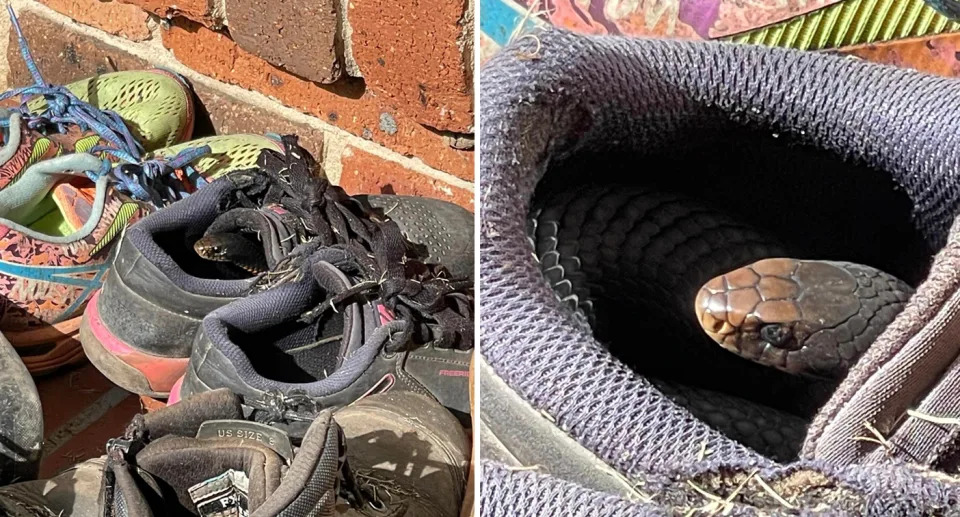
left=0, top=135, right=277, bottom=374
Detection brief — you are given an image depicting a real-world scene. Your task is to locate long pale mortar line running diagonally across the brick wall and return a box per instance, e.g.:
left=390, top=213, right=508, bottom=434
left=9, top=0, right=474, bottom=193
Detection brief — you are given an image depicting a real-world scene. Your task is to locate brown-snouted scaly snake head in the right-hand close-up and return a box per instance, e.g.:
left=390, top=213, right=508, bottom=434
left=695, top=258, right=875, bottom=377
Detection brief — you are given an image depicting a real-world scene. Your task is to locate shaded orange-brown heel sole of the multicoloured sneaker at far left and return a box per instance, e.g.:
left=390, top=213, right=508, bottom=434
left=4, top=316, right=86, bottom=376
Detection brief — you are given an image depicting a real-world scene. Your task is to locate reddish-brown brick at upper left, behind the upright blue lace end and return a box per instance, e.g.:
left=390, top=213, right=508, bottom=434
left=5, top=11, right=149, bottom=87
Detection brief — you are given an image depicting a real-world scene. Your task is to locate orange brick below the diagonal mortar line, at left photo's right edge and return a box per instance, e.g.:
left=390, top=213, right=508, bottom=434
left=340, top=146, right=473, bottom=211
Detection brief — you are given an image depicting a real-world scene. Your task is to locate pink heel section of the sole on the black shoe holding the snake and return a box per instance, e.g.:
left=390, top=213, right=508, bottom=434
left=86, top=291, right=190, bottom=393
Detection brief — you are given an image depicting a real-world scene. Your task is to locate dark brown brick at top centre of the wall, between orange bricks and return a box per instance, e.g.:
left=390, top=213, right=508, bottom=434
left=226, top=0, right=341, bottom=83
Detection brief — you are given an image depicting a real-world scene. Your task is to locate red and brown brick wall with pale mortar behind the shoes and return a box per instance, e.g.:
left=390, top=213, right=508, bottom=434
left=0, top=0, right=473, bottom=210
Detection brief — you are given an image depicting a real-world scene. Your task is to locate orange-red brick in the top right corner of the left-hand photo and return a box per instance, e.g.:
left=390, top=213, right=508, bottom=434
left=347, top=0, right=473, bottom=133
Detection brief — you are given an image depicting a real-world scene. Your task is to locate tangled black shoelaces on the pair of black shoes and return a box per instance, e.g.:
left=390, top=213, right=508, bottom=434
left=230, top=136, right=473, bottom=350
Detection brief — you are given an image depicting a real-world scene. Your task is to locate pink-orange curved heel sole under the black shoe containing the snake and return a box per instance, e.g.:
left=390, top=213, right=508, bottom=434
left=80, top=291, right=189, bottom=399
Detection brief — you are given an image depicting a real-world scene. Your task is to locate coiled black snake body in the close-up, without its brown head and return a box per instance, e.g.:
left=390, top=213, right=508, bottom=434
left=529, top=185, right=911, bottom=459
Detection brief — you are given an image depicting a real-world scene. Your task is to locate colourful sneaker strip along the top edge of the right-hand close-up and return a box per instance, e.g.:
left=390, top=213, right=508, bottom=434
left=479, top=0, right=960, bottom=77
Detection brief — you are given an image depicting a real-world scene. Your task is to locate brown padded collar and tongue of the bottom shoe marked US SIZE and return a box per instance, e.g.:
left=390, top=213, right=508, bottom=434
left=102, top=389, right=345, bottom=517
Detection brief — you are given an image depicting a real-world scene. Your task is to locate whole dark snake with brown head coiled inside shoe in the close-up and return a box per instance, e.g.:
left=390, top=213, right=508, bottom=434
left=528, top=185, right=913, bottom=460
